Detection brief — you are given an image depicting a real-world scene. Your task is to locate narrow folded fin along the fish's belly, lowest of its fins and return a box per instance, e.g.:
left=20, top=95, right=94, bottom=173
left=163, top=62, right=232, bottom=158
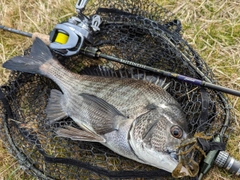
left=56, top=126, right=106, bottom=142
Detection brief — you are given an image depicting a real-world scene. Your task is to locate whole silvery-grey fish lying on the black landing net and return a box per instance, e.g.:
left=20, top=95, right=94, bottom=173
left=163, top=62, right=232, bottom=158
left=2, top=38, right=189, bottom=176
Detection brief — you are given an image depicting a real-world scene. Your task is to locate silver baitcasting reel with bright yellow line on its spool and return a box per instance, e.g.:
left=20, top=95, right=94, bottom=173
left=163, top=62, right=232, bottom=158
left=49, top=0, right=101, bottom=56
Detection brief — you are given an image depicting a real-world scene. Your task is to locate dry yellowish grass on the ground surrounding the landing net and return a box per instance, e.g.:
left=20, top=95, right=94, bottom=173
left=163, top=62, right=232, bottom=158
left=0, top=0, right=240, bottom=180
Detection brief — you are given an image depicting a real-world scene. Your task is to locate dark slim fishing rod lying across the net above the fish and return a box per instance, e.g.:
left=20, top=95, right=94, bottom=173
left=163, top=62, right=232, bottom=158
left=0, top=25, right=240, bottom=97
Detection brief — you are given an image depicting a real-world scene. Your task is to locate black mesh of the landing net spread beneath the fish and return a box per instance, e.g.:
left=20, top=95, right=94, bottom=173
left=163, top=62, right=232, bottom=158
left=0, top=0, right=233, bottom=179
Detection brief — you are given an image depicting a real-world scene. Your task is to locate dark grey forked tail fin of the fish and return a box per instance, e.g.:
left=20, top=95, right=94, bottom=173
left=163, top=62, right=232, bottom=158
left=3, top=38, right=53, bottom=74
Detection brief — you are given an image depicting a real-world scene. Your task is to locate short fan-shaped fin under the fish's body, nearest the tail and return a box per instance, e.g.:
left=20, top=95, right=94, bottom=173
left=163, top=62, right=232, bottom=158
left=45, top=89, right=67, bottom=124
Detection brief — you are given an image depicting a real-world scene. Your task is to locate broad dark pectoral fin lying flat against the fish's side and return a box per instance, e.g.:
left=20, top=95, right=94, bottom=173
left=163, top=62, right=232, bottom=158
left=80, top=93, right=126, bottom=134
